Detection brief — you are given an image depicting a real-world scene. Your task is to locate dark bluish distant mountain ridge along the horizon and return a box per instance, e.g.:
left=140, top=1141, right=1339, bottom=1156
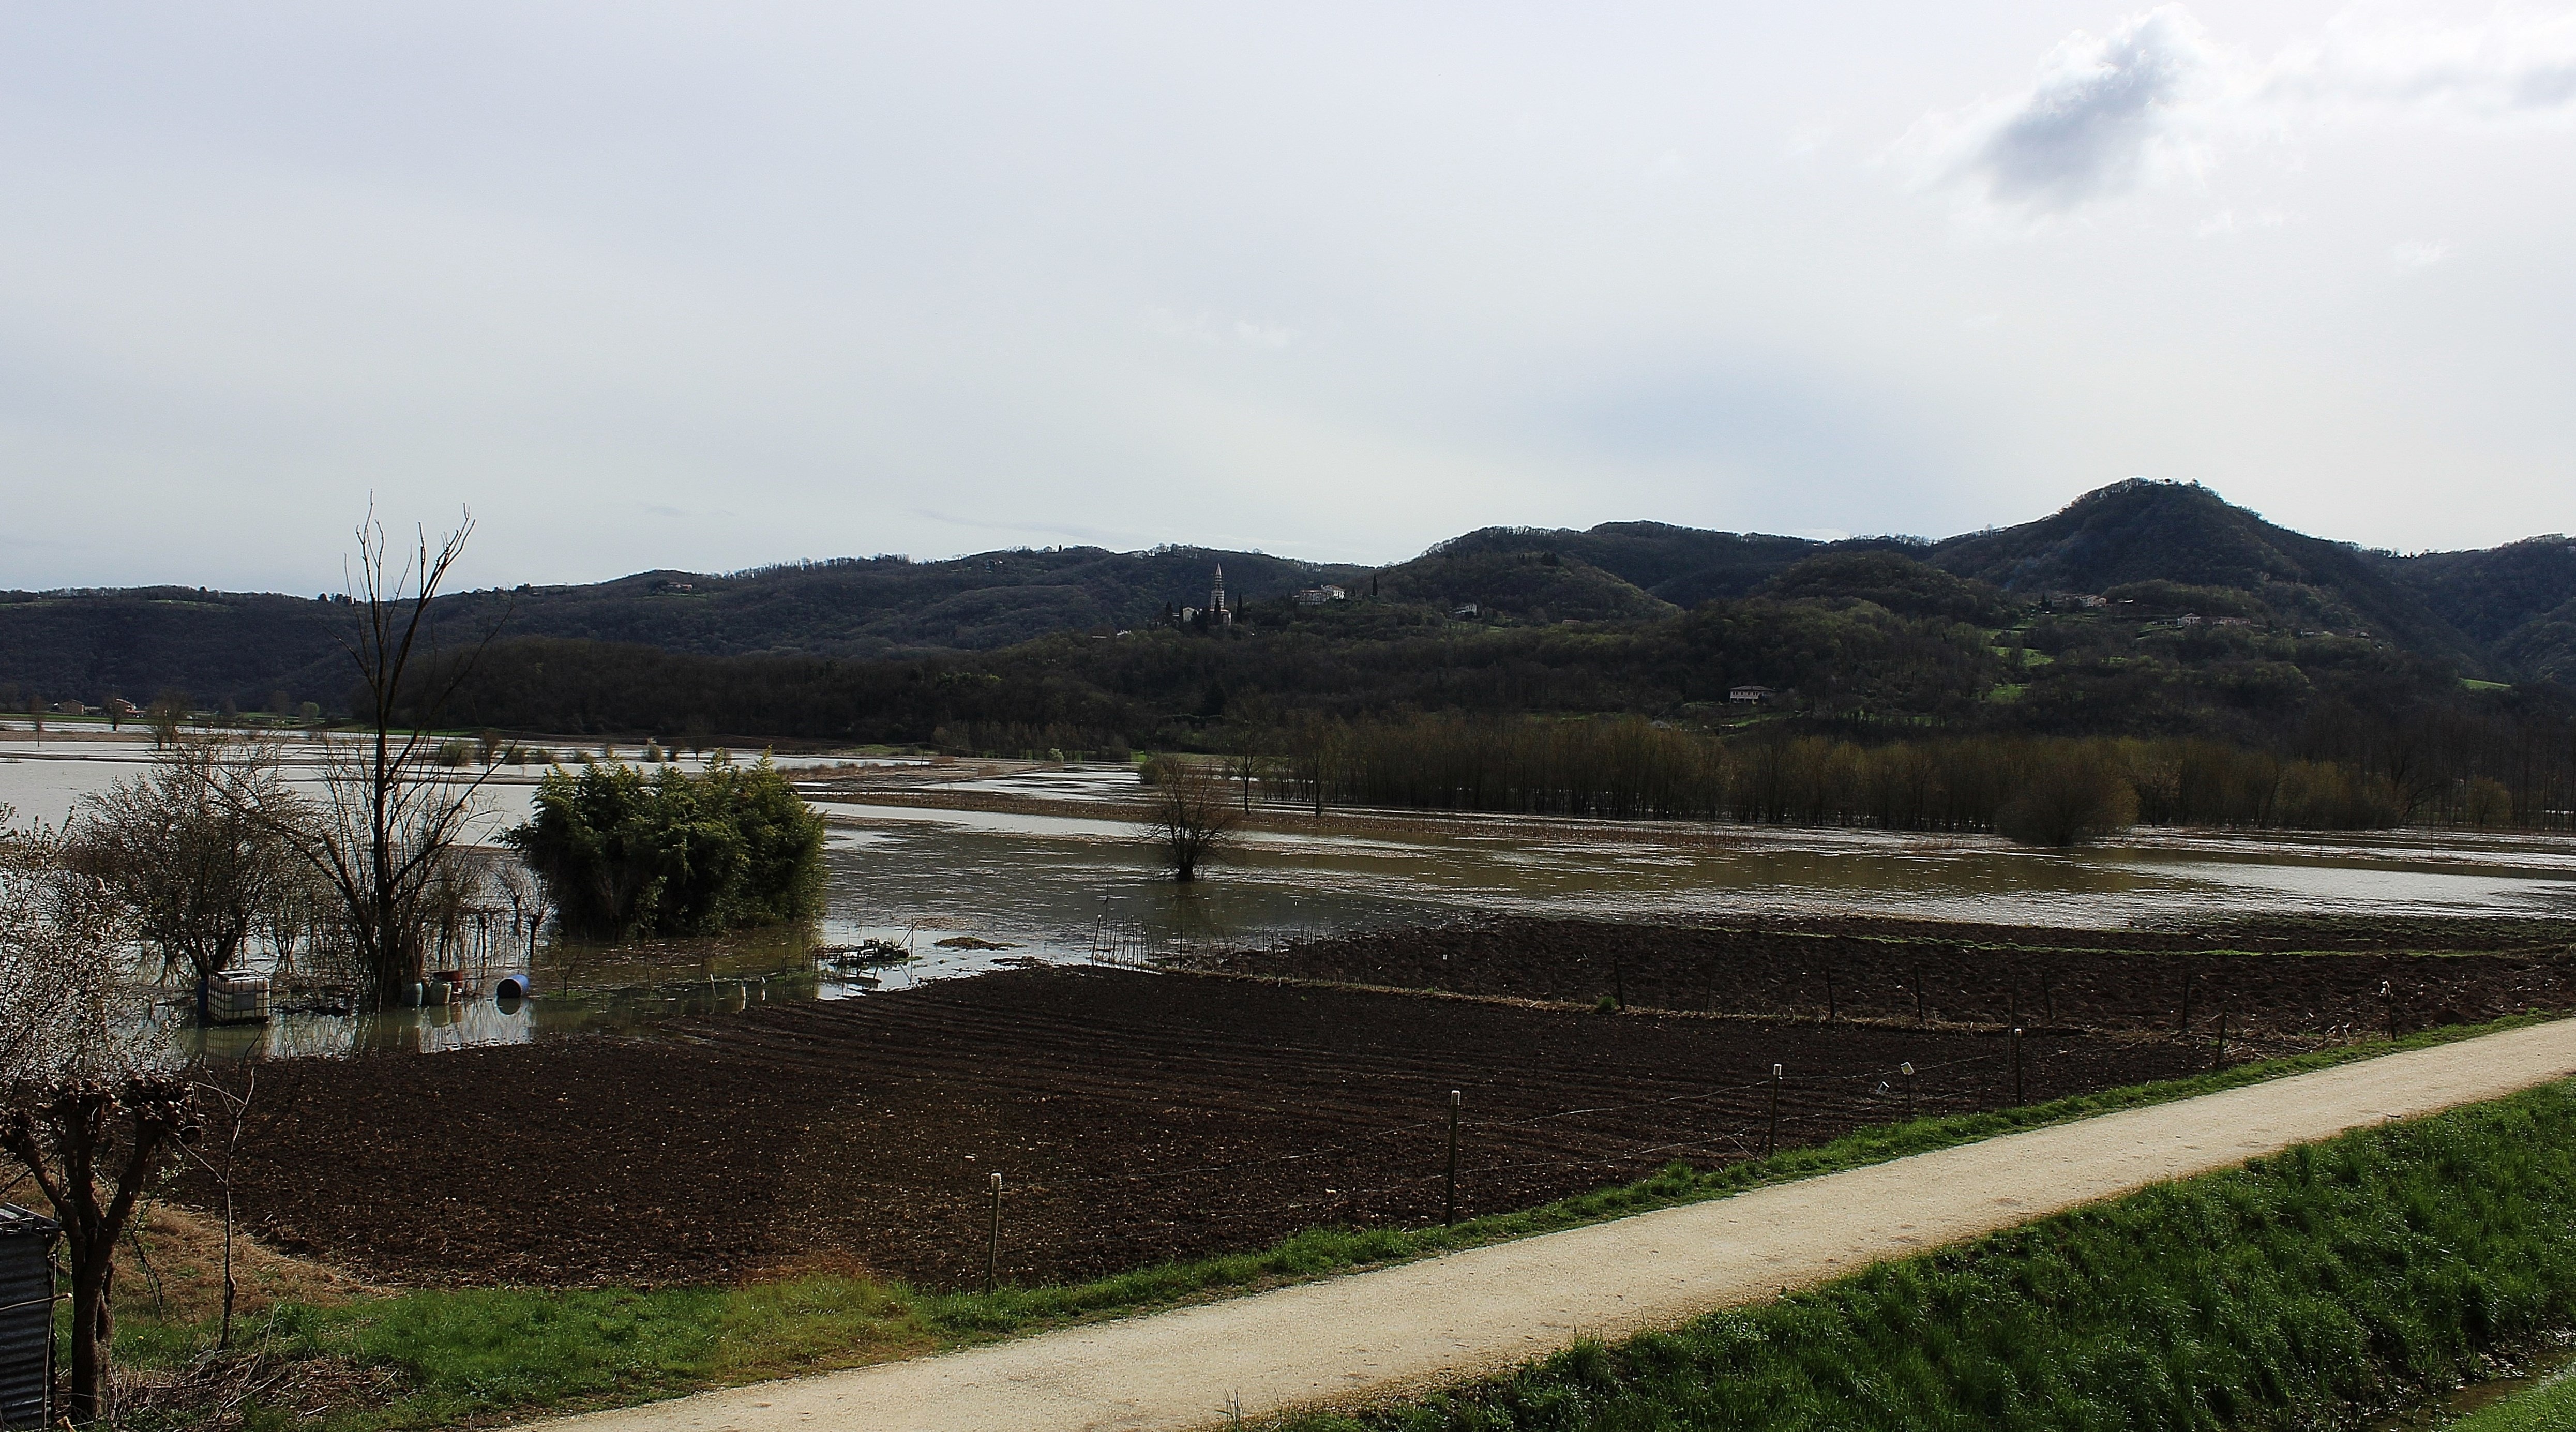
left=0, top=479, right=2576, bottom=706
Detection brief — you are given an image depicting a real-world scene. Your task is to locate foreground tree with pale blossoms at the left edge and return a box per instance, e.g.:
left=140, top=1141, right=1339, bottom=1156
left=0, top=811, right=193, bottom=1422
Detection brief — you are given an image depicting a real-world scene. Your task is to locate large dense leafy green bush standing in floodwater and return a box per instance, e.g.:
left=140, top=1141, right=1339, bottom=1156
left=502, top=755, right=822, bottom=940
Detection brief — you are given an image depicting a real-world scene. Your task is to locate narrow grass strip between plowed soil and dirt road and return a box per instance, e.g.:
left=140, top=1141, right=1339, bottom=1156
left=116, top=1015, right=2540, bottom=1432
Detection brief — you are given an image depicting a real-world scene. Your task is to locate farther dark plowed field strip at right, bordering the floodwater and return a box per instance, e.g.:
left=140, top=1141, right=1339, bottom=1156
left=1193, top=920, right=2576, bottom=1046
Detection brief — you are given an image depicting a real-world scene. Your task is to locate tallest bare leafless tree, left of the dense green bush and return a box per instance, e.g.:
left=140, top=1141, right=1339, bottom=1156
left=273, top=507, right=500, bottom=1007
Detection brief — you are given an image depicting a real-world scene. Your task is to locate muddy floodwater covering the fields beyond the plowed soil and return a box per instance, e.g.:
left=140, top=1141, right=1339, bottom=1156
left=15, top=739, right=2576, bottom=1053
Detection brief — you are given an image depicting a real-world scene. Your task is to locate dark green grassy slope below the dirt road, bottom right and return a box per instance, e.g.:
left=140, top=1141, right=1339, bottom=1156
left=1278, top=1084, right=2576, bottom=1432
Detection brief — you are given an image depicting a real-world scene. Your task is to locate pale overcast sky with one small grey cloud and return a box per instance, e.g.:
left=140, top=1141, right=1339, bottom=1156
left=0, top=0, right=2576, bottom=592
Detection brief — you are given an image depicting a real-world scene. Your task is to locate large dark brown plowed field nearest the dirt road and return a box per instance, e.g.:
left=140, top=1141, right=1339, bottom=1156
left=216, top=969, right=2213, bottom=1288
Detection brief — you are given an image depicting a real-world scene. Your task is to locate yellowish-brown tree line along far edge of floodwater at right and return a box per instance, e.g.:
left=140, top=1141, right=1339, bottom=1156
left=1244, top=716, right=2576, bottom=845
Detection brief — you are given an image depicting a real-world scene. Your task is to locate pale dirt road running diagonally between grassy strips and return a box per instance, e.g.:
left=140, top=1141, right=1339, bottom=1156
left=533, top=1020, right=2576, bottom=1432
